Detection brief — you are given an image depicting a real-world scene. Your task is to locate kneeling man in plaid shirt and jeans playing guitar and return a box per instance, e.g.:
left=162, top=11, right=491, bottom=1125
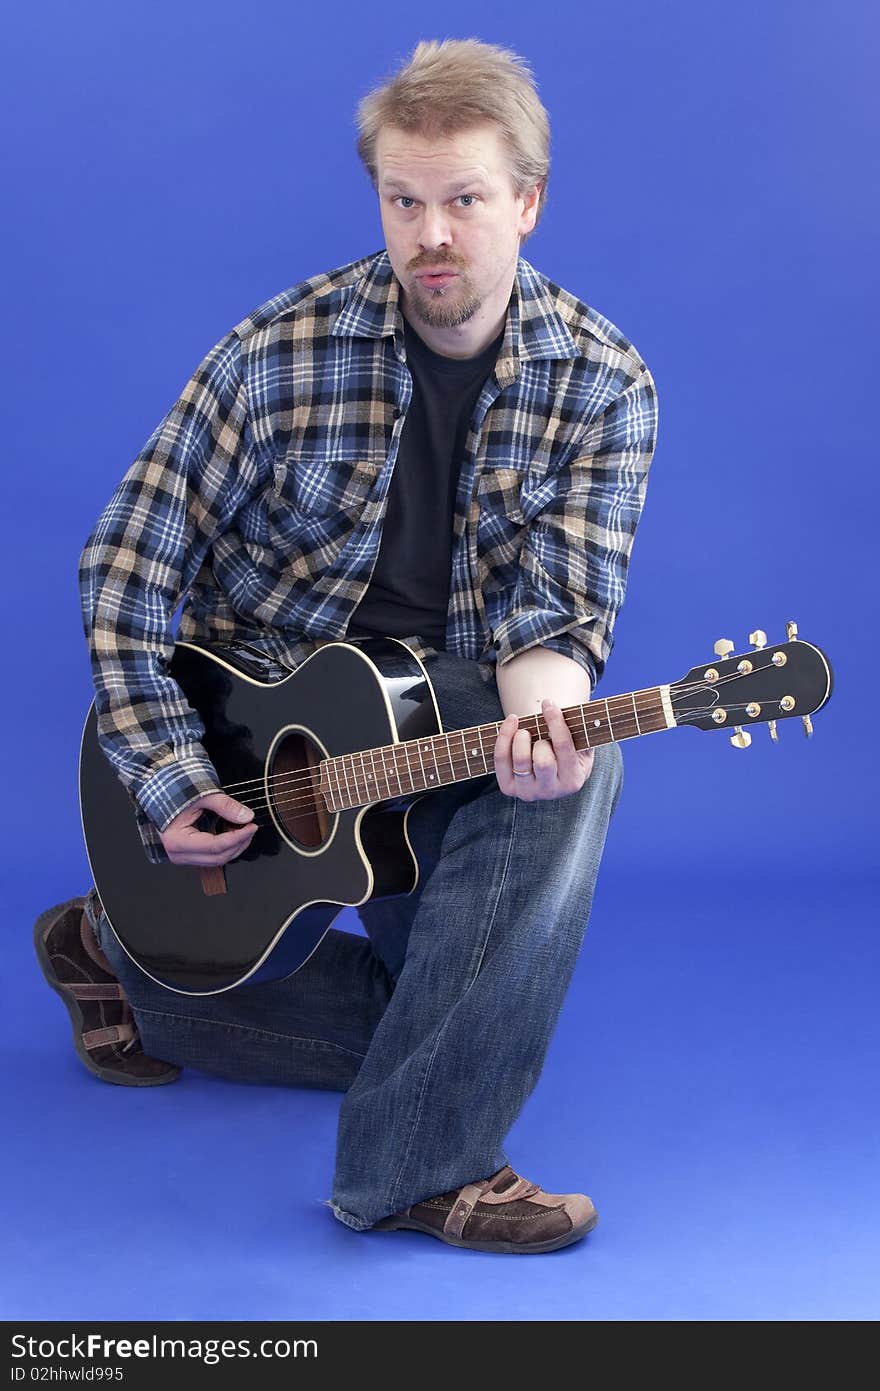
left=36, top=40, right=656, bottom=1253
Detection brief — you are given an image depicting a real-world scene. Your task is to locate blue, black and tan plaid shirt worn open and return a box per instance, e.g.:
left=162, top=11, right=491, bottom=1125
left=79, top=252, right=658, bottom=861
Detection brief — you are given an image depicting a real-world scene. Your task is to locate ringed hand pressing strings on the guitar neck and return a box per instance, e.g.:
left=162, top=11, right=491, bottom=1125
left=494, top=700, right=594, bottom=801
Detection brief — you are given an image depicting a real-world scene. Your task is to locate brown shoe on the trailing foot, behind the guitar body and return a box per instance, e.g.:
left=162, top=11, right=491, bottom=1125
left=33, top=899, right=181, bottom=1086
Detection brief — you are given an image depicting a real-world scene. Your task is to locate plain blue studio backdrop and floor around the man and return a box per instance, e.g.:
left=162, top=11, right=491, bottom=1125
left=0, top=0, right=880, bottom=1320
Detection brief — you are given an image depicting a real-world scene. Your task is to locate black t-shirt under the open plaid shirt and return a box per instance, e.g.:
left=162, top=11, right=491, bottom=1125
left=348, top=320, right=503, bottom=650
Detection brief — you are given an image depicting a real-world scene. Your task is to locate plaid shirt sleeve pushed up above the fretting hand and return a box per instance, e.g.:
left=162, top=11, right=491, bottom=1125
left=492, top=367, right=658, bottom=686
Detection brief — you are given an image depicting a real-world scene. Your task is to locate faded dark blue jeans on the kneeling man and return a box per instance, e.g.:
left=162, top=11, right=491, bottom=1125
left=89, top=652, right=623, bottom=1230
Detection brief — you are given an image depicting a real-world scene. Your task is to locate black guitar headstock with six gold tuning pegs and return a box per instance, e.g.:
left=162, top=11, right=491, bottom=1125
left=669, top=623, right=833, bottom=748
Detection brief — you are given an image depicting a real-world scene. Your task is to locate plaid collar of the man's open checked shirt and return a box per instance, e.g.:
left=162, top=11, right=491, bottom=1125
left=332, top=244, right=580, bottom=385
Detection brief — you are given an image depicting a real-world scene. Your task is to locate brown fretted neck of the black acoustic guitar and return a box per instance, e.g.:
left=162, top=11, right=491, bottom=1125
left=320, top=686, right=676, bottom=811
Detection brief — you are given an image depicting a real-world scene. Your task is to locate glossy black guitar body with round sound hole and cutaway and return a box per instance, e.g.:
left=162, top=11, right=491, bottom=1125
left=79, top=638, right=441, bottom=995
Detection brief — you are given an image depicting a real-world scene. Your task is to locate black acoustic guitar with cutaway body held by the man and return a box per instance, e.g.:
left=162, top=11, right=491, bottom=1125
left=79, top=623, right=831, bottom=995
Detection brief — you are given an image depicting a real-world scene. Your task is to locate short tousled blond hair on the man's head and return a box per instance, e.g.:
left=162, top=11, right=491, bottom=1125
left=356, top=39, right=551, bottom=233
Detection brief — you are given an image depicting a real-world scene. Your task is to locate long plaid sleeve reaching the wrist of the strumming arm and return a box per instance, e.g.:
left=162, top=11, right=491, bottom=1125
left=79, top=332, right=269, bottom=861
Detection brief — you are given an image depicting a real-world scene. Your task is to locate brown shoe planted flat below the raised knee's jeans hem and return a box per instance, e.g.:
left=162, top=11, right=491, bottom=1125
left=373, top=1166, right=599, bottom=1255
